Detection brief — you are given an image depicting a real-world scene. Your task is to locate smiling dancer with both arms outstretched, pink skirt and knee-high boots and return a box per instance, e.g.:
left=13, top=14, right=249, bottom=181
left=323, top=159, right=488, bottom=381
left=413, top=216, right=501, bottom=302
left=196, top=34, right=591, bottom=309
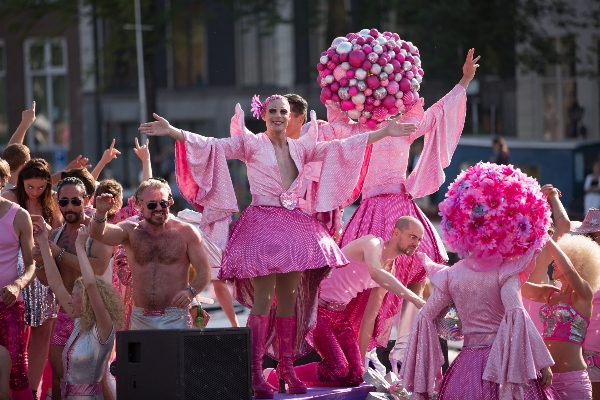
left=140, top=95, right=416, bottom=398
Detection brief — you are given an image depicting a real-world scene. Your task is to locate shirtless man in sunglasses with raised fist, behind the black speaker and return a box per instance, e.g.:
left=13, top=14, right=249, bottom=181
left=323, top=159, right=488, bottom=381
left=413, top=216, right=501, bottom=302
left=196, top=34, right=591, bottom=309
left=90, top=179, right=211, bottom=330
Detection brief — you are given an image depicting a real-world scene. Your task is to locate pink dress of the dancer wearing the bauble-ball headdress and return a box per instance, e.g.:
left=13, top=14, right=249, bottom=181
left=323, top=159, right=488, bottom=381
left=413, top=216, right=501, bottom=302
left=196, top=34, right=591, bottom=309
left=319, top=85, right=466, bottom=350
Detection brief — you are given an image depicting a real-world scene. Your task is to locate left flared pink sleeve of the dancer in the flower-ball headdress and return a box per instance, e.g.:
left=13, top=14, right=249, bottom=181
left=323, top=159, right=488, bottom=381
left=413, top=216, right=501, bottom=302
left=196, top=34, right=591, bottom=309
left=400, top=269, right=452, bottom=400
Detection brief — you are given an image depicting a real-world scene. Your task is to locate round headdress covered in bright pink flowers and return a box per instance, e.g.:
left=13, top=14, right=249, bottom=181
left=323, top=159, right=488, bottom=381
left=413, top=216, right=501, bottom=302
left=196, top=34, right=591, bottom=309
left=439, top=162, right=550, bottom=260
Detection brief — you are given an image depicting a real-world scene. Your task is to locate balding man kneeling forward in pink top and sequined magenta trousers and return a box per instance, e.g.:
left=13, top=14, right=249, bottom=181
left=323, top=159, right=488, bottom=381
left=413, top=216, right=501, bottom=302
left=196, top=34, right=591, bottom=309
left=269, top=216, right=425, bottom=386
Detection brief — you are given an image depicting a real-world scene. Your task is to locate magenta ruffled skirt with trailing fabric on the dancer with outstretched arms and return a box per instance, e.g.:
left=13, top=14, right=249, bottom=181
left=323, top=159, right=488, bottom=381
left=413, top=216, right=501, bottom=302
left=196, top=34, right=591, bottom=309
left=219, top=206, right=348, bottom=359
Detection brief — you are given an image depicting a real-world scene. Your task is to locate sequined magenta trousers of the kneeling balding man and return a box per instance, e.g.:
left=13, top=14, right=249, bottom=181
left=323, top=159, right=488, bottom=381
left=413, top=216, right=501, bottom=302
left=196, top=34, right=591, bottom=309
left=313, top=307, right=364, bottom=386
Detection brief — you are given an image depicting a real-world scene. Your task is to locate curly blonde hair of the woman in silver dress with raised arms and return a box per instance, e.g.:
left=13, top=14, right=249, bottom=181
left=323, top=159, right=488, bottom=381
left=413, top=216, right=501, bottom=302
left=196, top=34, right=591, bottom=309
left=75, top=277, right=125, bottom=332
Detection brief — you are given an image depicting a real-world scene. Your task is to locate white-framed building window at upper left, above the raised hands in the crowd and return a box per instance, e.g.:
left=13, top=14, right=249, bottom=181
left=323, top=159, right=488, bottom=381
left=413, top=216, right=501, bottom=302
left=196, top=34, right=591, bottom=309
left=24, top=38, right=70, bottom=149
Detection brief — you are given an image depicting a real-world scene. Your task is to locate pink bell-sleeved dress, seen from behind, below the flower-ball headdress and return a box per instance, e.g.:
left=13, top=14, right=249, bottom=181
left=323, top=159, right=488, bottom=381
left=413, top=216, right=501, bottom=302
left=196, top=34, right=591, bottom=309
left=400, top=251, right=560, bottom=400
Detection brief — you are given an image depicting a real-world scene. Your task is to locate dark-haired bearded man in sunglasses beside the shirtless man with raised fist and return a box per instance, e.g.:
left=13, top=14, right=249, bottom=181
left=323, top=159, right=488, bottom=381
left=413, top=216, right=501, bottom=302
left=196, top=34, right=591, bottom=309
left=33, top=177, right=112, bottom=399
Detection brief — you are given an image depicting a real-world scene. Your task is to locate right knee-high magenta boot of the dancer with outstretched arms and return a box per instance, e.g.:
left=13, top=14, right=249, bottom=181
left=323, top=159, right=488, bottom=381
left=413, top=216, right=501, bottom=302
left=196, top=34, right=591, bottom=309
left=275, top=316, right=306, bottom=394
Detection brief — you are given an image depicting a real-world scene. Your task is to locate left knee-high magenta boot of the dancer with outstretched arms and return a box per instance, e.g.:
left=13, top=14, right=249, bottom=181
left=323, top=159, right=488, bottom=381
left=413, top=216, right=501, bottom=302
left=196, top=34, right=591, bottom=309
left=246, top=314, right=275, bottom=399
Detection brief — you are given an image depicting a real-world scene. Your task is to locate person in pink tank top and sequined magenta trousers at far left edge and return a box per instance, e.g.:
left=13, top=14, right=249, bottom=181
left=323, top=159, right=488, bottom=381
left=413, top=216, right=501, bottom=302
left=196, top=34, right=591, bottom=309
left=0, top=159, right=35, bottom=400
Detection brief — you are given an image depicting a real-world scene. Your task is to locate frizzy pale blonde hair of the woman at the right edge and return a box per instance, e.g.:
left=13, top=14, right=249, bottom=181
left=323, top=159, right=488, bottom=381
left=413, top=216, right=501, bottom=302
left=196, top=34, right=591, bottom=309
left=556, top=235, right=600, bottom=293
